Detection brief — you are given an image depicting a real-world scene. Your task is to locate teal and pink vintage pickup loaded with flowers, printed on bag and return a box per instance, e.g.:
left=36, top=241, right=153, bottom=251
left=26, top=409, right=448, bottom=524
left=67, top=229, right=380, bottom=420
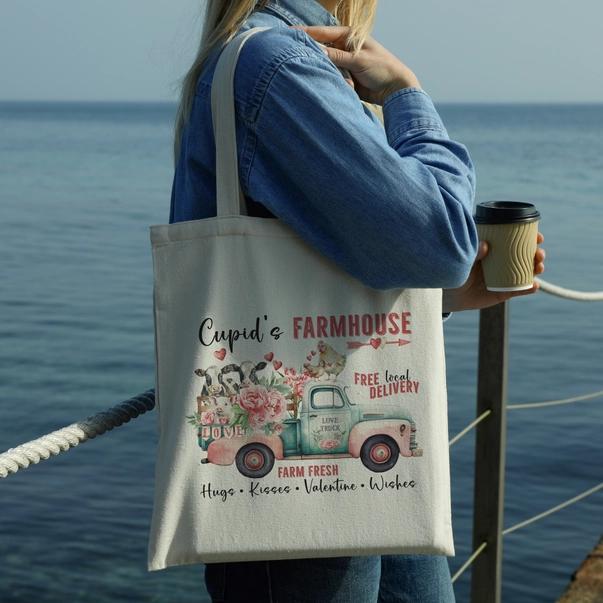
left=187, top=375, right=422, bottom=478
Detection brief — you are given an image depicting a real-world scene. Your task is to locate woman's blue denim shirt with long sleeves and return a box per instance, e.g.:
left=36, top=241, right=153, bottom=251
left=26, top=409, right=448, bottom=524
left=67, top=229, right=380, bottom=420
left=169, top=0, right=478, bottom=316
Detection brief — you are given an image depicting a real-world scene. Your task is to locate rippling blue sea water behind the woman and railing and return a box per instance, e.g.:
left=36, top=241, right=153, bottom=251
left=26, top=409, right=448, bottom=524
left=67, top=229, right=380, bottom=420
left=0, top=103, right=603, bottom=603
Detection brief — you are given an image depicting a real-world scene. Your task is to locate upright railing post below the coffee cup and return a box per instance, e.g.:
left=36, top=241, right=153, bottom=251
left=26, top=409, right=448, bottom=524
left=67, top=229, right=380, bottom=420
left=471, top=302, right=508, bottom=603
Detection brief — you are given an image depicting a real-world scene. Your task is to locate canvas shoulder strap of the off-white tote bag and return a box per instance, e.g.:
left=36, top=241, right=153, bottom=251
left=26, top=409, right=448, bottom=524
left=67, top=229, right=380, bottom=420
left=211, top=27, right=270, bottom=216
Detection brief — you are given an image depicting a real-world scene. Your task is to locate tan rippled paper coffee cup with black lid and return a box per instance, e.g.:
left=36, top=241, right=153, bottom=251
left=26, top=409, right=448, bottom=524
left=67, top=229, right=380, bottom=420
left=473, top=201, right=540, bottom=291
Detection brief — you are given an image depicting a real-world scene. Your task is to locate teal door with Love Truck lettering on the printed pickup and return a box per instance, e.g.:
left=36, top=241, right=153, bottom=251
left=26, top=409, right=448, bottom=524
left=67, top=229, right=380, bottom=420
left=303, top=386, right=352, bottom=454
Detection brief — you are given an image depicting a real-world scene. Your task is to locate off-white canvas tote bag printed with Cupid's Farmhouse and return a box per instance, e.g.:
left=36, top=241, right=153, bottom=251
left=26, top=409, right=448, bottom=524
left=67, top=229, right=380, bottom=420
left=148, top=27, right=454, bottom=571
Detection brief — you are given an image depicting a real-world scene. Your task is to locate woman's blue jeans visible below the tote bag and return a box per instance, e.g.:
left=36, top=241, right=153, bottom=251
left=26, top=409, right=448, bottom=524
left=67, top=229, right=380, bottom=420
left=205, top=555, right=455, bottom=603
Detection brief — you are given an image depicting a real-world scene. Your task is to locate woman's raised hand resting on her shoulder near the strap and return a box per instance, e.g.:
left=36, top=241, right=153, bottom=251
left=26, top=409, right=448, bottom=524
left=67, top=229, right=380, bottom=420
left=290, top=25, right=421, bottom=105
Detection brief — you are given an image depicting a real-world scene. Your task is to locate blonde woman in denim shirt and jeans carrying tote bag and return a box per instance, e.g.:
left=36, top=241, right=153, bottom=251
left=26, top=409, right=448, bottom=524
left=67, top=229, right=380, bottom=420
left=170, top=0, right=544, bottom=603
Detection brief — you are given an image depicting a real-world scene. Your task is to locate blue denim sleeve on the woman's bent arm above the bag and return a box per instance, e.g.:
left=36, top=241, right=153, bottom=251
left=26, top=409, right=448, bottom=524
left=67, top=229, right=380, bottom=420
left=241, top=36, right=478, bottom=289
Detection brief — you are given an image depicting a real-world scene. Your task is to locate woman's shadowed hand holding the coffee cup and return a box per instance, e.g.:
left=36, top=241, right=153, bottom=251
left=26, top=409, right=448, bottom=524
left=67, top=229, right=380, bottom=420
left=442, top=232, right=546, bottom=312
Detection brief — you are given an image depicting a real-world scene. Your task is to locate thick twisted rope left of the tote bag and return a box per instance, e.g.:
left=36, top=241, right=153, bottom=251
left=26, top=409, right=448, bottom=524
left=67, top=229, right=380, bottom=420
left=0, top=389, right=155, bottom=478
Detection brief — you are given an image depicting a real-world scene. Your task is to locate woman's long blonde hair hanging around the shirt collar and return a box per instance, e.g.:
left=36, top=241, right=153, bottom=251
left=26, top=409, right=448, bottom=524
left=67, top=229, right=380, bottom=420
left=174, top=0, right=377, bottom=162
